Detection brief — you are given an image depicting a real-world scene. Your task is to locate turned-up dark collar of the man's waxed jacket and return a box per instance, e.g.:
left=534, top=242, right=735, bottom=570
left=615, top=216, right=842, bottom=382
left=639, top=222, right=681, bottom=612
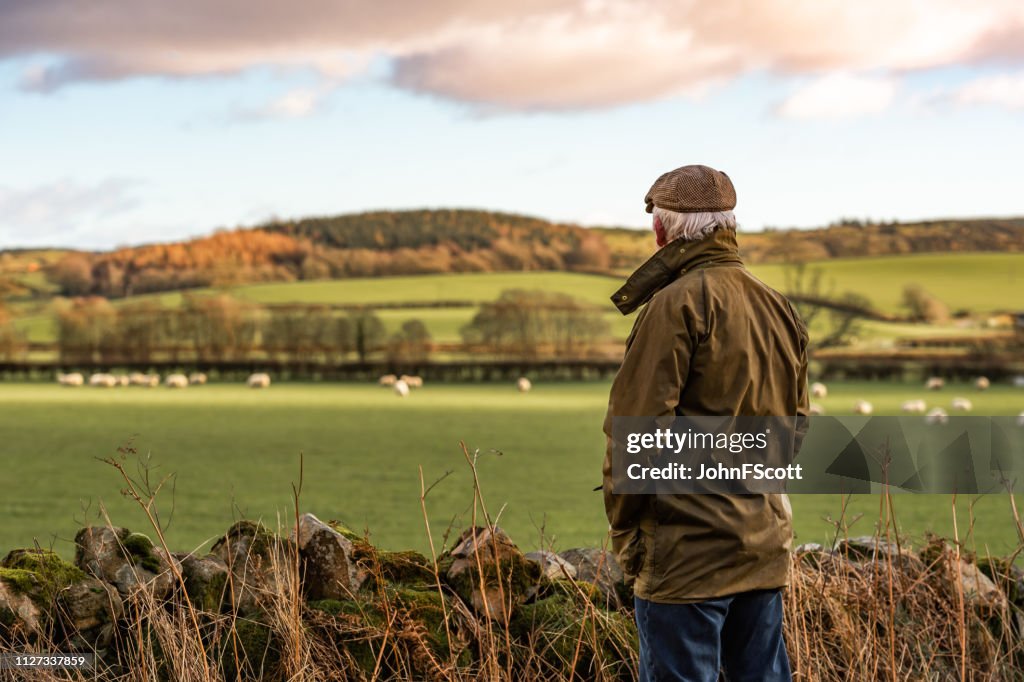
left=611, top=229, right=743, bottom=315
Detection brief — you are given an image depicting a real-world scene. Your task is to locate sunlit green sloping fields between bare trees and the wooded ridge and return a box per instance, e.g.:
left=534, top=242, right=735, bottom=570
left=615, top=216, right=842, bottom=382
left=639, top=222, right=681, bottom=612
left=9, top=253, right=1024, bottom=343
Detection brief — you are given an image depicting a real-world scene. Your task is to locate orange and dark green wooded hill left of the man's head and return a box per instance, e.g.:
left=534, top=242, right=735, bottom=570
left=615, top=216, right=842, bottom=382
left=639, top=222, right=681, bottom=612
left=47, top=206, right=610, bottom=298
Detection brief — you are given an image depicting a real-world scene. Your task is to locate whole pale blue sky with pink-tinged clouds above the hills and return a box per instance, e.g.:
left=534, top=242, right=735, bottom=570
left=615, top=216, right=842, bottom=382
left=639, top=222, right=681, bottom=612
left=0, top=0, right=1024, bottom=249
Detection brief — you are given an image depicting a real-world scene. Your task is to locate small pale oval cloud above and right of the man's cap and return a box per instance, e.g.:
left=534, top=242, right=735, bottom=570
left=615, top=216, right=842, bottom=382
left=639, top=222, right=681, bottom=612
left=776, top=73, right=897, bottom=119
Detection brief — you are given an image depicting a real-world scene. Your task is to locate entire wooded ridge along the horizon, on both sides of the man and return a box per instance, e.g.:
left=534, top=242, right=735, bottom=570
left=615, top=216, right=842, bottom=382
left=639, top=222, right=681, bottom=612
left=6, top=210, right=1024, bottom=303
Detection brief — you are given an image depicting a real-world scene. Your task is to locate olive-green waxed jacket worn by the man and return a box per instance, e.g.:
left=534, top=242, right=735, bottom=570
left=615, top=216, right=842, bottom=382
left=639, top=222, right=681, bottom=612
left=603, top=228, right=808, bottom=603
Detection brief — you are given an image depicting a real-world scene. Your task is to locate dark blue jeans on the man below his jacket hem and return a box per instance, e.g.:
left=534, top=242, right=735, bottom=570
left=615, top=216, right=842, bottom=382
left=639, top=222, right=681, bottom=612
left=634, top=590, right=793, bottom=682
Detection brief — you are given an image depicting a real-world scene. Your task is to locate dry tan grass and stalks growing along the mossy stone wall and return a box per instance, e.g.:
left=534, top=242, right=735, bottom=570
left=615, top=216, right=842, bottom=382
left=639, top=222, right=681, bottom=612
left=0, top=450, right=1024, bottom=682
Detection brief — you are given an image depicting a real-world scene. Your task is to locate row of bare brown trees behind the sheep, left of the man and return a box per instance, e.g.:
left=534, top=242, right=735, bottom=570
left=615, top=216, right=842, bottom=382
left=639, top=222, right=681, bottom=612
left=44, top=290, right=608, bottom=366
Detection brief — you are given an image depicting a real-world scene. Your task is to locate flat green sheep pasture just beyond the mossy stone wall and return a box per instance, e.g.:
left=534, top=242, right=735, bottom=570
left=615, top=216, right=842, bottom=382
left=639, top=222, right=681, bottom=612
left=0, top=383, right=1024, bottom=555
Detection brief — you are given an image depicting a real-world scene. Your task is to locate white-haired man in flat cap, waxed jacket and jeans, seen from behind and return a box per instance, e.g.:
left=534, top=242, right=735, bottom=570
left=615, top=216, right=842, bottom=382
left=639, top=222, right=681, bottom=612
left=604, top=166, right=808, bottom=682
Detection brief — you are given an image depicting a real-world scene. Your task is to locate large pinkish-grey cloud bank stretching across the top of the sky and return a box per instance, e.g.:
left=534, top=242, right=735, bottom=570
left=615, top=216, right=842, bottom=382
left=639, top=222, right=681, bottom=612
left=6, top=0, right=1024, bottom=110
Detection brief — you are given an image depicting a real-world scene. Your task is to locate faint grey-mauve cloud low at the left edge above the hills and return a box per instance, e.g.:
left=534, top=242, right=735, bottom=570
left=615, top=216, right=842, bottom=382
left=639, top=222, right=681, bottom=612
left=0, top=178, right=139, bottom=248
